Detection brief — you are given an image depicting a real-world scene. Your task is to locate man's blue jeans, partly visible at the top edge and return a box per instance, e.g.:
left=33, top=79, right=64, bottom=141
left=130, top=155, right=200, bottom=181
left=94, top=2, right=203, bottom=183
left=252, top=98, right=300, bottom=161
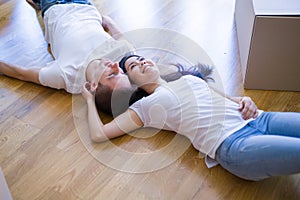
left=33, top=0, right=93, bottom=16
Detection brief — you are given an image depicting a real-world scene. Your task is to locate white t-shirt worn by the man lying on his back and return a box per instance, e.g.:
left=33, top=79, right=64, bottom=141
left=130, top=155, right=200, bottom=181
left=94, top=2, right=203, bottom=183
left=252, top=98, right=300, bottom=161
left=39, top=4, right=131, bottom=94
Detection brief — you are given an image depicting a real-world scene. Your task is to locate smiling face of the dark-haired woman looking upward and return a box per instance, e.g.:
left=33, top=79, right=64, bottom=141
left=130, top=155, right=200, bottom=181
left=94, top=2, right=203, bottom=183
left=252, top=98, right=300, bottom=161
left=125, top=57, right=160, bottom=87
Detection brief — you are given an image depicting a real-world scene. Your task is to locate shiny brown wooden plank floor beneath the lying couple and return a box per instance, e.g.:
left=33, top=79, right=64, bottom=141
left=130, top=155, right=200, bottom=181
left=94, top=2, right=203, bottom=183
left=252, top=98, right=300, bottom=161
left=0, top=0, right=300, bottom=200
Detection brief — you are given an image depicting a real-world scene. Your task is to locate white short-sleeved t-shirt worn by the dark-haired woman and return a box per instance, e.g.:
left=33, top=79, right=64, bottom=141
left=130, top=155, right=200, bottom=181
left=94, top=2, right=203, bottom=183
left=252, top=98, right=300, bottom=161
left=130, top=75, right=262, bottom=167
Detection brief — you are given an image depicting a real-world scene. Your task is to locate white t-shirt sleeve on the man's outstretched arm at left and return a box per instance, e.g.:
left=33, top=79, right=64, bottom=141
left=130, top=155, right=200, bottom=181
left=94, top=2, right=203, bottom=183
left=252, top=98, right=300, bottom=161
left=39, top=61, right=66, bottom=89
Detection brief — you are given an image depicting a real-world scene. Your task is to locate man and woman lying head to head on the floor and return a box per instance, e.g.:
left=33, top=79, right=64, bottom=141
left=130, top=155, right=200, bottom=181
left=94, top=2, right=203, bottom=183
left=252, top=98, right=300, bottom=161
left=0, top=0, right=300, bottom=181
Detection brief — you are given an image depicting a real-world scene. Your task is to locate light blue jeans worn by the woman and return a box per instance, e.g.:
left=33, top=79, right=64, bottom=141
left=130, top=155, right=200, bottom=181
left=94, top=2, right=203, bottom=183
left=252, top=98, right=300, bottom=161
left=216, top=112, right=300, bottom=181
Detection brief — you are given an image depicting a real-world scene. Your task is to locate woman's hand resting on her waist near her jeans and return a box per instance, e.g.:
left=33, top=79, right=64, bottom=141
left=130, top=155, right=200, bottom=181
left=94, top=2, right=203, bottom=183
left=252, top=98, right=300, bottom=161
left=239, top=97, right=258, bottom=120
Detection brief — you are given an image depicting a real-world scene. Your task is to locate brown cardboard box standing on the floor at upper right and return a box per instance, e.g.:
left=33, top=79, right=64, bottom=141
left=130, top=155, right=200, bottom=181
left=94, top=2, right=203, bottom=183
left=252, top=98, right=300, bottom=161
left=235, top=0, right=300, bottom=91
